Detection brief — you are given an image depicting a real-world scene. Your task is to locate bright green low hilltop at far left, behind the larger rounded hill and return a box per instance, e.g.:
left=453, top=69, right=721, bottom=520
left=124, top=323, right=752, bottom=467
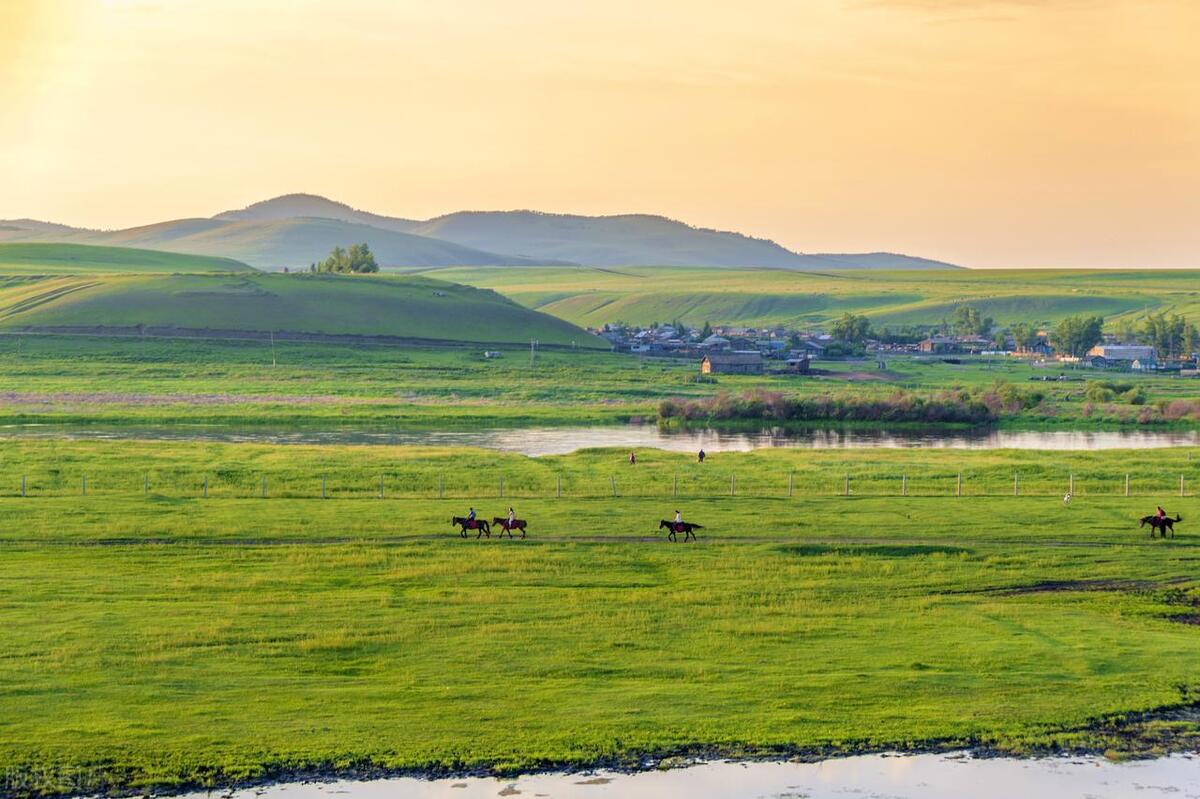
left=0, top=242, right=253, bottom=275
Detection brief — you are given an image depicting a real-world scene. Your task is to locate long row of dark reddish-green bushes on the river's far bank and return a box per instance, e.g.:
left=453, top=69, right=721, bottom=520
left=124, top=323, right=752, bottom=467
left=659, top=391, right=1004, bottom=425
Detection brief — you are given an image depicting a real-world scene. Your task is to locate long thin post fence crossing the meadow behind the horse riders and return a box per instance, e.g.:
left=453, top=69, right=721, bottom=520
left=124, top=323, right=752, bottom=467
left=0, top=468, right=1194, bottom=500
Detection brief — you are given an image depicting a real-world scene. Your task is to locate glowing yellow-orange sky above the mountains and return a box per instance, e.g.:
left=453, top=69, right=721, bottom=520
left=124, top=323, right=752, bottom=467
left=0, top=0, right=1200, bottom=268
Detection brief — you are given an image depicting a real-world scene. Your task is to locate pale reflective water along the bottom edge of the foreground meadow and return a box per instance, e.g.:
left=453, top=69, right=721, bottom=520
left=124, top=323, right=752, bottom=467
left=177, top=755, right=1200, bottom=799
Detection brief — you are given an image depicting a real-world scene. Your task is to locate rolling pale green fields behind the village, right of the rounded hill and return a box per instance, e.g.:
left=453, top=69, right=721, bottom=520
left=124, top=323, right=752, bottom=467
left=415, top=266, right=1200, bottom=328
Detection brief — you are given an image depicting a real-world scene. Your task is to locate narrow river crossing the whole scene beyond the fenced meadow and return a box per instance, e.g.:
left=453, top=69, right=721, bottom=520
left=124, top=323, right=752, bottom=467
left=0, top=425, right=1200, bottom=456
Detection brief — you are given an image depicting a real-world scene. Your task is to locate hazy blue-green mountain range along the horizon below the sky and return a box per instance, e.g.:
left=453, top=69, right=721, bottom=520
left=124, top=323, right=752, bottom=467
left=0, top=194, right=958, bottom=271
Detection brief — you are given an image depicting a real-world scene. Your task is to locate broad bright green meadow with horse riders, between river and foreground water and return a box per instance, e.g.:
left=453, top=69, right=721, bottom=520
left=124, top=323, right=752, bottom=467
left=0, top=443, right=1200, bottom=794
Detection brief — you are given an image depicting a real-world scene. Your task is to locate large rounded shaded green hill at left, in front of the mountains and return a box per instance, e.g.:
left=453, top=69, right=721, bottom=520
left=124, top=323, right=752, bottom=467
left=0, top=274, right=607, bottom=348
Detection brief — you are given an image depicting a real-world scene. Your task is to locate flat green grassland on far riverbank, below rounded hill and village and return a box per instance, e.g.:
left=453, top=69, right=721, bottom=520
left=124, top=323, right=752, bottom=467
left=0, top=335, right=1200, bottom=428
